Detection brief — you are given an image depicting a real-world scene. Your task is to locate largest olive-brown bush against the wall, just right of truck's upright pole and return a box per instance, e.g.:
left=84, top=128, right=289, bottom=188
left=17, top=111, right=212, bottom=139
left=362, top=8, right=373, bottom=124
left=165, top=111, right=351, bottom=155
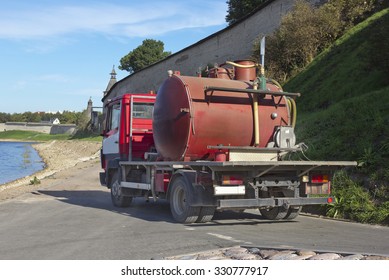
left=254, top=0, right=339, bottom=82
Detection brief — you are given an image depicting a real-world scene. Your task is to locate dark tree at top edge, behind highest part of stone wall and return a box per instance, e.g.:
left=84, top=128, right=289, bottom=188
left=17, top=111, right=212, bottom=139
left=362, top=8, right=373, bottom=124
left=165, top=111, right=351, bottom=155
left=226, top=0, right=268, bottom=25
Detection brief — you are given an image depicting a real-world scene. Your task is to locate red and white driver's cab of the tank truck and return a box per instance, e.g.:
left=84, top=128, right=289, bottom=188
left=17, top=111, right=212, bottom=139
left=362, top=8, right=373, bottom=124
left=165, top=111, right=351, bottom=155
left=100, top=92, right=156, bottom=185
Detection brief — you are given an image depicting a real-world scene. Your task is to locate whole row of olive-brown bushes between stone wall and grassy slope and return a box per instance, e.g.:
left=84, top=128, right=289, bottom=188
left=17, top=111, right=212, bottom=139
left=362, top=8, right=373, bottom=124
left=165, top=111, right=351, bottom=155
left=254, top=0, right=379, bottom=82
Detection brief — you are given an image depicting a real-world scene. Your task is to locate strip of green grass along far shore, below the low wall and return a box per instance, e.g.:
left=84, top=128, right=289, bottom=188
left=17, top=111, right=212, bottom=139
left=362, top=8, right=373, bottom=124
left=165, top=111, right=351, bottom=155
left=0, top=130, right=102, bottom=142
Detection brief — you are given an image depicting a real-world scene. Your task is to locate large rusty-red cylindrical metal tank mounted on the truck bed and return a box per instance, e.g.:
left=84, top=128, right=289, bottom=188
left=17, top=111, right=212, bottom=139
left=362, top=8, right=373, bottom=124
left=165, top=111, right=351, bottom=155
left=153, top=75, right=290, bottom=161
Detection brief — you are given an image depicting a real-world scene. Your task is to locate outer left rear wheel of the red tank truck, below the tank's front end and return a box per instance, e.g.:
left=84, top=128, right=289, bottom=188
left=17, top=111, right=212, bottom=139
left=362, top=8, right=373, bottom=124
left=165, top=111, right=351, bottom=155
left=170, top=177, right=200, bottom=224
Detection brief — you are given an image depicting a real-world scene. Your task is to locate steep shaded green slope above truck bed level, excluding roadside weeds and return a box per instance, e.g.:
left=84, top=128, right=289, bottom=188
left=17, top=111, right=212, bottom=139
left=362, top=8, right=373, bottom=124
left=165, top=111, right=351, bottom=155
left=284, top=9, right=389, bottom=166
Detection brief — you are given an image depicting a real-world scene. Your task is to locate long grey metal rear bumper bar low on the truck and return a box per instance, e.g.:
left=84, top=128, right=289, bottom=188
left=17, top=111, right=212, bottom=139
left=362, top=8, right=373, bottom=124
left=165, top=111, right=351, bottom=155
left=217, top=197, right=330, bottom=209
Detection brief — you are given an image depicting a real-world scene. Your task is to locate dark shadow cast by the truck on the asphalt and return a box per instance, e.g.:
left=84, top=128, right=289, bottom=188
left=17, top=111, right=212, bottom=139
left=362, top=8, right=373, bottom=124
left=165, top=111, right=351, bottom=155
left=38, top=190, right=295, bottom=226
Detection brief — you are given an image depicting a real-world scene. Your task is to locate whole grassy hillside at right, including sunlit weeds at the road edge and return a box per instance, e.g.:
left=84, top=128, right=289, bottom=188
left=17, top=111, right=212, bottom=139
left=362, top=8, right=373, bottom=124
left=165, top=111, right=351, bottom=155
left=284, top=9, right=389, bottom=224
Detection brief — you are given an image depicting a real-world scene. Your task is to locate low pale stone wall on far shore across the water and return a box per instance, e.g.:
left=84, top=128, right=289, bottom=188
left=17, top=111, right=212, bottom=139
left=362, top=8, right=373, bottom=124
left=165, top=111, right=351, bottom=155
left=0, top=122, right=77, bottom=135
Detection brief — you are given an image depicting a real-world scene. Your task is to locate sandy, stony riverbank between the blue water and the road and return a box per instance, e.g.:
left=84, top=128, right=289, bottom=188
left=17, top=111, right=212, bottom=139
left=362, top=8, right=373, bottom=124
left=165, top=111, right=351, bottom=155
left=0, top=140, right=101, bottom=201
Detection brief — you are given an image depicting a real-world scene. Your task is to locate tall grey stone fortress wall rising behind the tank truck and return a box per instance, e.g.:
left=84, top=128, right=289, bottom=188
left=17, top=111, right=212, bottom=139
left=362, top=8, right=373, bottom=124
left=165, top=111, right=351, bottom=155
left=102, top=0, right=322, bottom=102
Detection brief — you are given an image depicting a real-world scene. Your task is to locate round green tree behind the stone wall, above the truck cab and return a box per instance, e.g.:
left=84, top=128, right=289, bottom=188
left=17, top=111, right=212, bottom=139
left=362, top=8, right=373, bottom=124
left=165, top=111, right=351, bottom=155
left=119, top=39, right=171, bottom=73
